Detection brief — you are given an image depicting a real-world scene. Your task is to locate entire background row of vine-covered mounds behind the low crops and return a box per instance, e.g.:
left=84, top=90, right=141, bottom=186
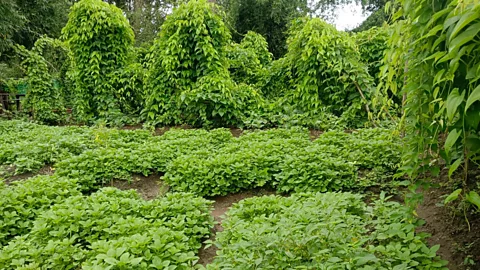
left=0, top=0, right=382, bottom=129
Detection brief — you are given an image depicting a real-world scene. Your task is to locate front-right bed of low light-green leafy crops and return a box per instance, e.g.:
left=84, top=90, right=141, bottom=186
left=208, top=193, right=447, bottom=270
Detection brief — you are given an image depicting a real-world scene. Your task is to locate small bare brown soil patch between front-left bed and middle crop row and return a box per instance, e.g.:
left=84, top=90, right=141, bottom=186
left=111, top=174, right=168, bottom=200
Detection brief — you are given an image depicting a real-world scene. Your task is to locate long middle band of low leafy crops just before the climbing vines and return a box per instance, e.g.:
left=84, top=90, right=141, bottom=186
left=0, top=121, right=401, bottom=196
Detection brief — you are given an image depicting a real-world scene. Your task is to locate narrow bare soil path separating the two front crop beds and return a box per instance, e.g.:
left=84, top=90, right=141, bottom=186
left=198, top=189, right=275, bottom=266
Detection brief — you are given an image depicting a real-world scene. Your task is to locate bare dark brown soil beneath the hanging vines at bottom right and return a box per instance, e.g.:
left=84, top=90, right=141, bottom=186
left=417, top=182, right=480, bottom=270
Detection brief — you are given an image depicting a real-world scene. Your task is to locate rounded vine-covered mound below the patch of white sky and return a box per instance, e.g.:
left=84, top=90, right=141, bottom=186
left=286, top=18, right=372, bottom=119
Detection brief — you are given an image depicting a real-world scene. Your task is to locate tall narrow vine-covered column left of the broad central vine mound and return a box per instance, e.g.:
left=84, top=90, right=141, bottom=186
left=63, top=0, right=134, bottom=119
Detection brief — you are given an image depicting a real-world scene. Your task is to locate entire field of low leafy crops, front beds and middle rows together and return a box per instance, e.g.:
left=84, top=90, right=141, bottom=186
left=0, top=121, right=446, bottom=269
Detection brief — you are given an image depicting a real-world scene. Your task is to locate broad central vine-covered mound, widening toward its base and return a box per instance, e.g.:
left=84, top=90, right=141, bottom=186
left=144, top=0, right=257, bottom=125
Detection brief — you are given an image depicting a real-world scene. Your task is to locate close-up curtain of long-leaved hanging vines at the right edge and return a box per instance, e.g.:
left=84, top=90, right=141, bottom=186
left=384, top=0, right=480, bottom=206
